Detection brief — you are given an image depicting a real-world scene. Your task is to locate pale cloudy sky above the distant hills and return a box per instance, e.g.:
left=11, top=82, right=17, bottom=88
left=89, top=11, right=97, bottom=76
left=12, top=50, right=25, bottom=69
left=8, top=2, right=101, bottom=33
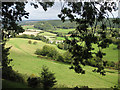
left=23, top=1, right=120, bottom=20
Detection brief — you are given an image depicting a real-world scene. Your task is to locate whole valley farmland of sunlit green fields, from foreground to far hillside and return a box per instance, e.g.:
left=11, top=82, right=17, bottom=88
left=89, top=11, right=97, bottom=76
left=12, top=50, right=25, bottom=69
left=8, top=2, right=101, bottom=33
left=3, top=20, right=118, bottom=88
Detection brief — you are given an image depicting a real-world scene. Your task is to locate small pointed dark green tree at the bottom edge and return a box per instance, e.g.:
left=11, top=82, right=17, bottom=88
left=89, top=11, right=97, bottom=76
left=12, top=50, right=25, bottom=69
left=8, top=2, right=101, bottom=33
left=41, top=66, right=57, bottom=90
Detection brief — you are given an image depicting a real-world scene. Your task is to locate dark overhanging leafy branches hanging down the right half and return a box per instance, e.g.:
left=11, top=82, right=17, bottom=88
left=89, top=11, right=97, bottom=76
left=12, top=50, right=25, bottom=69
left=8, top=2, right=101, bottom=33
left=58, top=2, right=119, bottom=75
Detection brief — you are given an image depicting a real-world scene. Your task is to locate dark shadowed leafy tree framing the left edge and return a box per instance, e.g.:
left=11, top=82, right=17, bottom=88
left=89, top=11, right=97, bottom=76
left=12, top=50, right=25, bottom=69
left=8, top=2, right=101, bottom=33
left=0, top=2, right=28, bottom=79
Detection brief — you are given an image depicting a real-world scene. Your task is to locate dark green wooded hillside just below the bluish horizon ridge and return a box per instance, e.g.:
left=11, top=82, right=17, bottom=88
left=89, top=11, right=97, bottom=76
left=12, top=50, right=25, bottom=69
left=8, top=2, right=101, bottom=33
left=34, top=20, right=77, bottom=31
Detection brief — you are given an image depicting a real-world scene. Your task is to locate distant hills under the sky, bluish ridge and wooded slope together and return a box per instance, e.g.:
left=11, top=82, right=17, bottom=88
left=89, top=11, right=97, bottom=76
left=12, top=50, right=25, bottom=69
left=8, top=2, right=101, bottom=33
left=19, top=18, right=120, bottom=31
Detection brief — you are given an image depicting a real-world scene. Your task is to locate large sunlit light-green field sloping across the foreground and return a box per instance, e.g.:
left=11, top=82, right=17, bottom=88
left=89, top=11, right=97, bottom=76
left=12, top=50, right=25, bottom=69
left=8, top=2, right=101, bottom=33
left=6, top=38, right=118, bottom=88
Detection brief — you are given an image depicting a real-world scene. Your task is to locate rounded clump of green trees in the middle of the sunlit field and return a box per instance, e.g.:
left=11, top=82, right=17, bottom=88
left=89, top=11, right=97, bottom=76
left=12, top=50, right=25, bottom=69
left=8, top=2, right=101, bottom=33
left=35, top=45, right=72, bottom=64
